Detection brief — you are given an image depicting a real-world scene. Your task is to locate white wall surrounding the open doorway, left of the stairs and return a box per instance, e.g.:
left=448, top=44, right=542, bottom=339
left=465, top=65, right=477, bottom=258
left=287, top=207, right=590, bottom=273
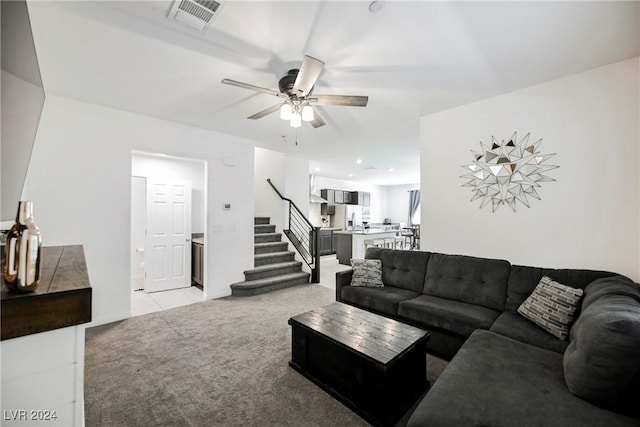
left=24, top=95, right=254, bottom=324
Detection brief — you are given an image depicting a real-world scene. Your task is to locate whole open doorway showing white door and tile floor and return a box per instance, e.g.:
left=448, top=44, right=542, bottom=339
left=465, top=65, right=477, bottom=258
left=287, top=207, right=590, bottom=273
left=130, top=151, right=206, bottom=315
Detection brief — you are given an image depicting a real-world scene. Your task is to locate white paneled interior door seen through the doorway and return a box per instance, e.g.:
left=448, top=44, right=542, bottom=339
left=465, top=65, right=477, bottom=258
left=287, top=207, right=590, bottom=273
left=144, top=178, right=191, bottom=292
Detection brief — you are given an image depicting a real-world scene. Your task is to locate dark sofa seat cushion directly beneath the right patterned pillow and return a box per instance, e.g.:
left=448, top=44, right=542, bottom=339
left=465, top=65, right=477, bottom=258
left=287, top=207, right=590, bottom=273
left=489, top=311, right=569, bottom=353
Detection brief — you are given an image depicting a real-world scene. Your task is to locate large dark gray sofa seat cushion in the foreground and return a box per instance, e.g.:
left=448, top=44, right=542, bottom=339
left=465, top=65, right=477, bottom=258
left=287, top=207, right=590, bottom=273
left=408, top=330, right=638, bottom=427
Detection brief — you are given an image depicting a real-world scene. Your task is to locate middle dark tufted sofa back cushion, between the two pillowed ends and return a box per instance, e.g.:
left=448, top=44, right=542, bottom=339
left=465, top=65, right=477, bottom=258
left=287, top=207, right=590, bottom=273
left=422, top=253, right=511, bottom=311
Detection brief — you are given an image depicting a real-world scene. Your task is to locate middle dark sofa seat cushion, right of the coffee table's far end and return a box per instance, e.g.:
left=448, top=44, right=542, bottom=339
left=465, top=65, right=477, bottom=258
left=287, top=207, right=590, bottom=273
left=398, top=295, right=500, bottom=337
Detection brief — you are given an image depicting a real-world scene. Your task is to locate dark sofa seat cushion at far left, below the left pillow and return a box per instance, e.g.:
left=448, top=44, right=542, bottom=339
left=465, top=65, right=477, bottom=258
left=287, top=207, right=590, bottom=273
left=341, top=286, right=420, bottom=316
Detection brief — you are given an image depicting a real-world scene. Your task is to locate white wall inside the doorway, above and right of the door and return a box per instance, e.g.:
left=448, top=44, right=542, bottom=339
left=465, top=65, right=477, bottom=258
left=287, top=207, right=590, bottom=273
left=131, top=153, right=205, bottom=233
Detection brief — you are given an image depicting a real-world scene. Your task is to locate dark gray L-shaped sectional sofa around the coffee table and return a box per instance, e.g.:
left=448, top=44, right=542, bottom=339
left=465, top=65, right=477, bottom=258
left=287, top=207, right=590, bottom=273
left=336, top=248, right=640, bottom=426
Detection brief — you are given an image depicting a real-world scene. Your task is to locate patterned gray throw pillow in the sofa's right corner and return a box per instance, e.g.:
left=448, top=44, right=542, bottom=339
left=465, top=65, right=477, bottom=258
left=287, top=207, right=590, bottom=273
left=518, top=276, right=583, bottom=340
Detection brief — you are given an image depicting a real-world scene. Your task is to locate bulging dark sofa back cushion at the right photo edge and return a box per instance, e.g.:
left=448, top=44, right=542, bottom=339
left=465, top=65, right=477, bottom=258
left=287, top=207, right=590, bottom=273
left=563, top=276, right=640, bottom=415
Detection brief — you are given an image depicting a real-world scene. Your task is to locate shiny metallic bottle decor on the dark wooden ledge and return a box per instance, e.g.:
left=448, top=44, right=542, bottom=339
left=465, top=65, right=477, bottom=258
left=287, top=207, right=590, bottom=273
left=3, top=200, right=42, bottom=292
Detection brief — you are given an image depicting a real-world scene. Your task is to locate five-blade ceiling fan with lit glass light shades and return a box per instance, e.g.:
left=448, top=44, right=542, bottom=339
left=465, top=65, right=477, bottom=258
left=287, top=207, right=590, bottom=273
left=222, top=55, right=369, bottom=128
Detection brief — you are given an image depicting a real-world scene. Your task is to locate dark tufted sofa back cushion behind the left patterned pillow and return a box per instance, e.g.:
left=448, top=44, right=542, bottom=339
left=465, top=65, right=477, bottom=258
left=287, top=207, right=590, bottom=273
left=365, top=248, right=431, bottom=292
